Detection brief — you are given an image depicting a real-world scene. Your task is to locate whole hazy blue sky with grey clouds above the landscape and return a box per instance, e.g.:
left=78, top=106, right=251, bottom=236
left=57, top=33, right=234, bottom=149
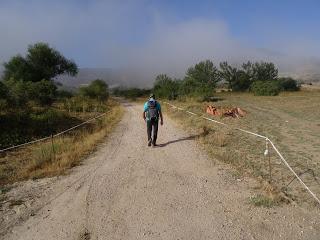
left=0, top=0, right=320, bottom=81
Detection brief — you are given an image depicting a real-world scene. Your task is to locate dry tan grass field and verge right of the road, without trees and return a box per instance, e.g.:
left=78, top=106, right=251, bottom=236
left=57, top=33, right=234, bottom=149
left=165, top=91, right=320, bottom=206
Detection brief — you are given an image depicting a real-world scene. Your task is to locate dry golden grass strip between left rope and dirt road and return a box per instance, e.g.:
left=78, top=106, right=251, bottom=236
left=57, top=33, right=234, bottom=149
left=0, top=100, right=123, bottom=185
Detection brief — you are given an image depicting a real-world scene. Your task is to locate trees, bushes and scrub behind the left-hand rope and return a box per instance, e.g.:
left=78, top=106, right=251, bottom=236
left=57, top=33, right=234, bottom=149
left=0, top=43, right=109, bottom=148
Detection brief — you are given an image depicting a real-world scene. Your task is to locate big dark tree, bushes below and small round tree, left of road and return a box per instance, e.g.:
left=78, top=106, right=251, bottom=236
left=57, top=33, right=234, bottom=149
left=0, top=43, right=109, bottom=111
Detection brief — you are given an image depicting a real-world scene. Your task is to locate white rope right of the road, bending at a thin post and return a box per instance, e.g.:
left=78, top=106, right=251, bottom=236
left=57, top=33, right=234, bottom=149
left=164, top=102, right=320, bottom=204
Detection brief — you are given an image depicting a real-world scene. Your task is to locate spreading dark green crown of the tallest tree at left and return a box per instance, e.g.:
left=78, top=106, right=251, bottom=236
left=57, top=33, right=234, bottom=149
left=3, top=43, right=78, bottom=82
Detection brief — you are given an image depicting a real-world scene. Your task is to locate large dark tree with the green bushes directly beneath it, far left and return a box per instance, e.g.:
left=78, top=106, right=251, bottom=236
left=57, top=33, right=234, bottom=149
left=3, top=43, right=78, bottom=108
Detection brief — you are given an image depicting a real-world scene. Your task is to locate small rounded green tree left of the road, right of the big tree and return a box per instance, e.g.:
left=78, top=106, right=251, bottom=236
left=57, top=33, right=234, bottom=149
left=79, top=79, right=109, bottom=101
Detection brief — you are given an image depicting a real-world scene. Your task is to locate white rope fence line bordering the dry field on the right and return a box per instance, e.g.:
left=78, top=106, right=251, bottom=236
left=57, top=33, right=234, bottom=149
left=164, top=102, right=320, bottom=205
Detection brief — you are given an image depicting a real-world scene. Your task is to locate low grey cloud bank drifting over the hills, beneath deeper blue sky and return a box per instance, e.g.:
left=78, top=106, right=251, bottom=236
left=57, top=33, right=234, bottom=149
left=0, top=0, right=320, bottom=86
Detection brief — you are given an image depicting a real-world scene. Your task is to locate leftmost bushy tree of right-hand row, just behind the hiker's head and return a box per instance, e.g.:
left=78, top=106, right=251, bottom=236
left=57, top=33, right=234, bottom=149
left=153, top=74, right=179, bottom=100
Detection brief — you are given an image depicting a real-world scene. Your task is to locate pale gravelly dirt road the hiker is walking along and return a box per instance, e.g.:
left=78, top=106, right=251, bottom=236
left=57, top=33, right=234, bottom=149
left=0, top=104, right=320, bottom=240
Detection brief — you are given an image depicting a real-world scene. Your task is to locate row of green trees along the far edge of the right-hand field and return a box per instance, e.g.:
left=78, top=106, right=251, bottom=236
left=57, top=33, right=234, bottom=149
left=154, top=60, right=299, bottom=99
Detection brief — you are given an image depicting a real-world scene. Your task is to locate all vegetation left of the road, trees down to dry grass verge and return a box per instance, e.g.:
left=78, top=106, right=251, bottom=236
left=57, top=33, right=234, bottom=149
left=0, top=43, right=122, bottom=185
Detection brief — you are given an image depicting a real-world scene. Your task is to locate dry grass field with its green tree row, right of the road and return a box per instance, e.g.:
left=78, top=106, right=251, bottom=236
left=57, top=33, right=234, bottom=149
left=149, top=60, right=320, bottom=207
